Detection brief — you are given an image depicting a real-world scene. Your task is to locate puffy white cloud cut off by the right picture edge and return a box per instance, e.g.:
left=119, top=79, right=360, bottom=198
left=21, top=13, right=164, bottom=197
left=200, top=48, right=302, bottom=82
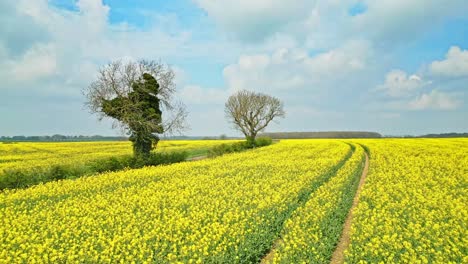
left=430, top=46, right=468, bottom=77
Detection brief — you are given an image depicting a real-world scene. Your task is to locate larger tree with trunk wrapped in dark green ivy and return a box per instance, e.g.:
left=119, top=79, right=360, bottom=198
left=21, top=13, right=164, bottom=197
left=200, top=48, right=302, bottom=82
left=84, top=60, right=187, bottom=156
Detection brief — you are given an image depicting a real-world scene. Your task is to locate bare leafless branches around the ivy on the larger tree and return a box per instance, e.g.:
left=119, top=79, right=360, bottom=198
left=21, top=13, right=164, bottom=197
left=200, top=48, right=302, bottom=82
left=82, top=60, right=188, bottom=138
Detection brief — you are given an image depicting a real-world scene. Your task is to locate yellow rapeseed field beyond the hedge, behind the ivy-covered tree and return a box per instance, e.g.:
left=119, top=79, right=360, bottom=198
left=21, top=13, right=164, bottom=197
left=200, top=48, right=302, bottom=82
left=0, top=140, right=236, bottom=189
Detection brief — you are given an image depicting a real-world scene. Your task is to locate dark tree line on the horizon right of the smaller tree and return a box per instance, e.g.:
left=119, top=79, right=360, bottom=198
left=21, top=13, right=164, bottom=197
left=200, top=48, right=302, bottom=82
left=260, top=131, right=382, bottom=139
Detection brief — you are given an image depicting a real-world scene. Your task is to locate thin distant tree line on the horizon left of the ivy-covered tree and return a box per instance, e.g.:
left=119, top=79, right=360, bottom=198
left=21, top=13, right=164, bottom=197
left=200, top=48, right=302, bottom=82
left=0, top=134, right=128, bottom=142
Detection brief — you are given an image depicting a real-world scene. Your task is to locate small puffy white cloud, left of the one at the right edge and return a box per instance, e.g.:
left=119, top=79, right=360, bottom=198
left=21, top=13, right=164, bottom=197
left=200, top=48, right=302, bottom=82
left=377, top=70, right=427, bottom=97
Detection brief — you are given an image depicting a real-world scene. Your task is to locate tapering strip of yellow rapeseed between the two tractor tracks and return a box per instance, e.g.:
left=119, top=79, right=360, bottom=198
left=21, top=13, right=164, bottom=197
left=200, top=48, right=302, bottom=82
left=273, top=145, right=365, bottom=263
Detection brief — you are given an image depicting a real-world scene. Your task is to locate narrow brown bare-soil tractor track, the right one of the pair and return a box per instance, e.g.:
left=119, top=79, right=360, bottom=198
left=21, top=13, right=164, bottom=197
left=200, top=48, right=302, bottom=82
left=330, top=153, right=369, bottom=264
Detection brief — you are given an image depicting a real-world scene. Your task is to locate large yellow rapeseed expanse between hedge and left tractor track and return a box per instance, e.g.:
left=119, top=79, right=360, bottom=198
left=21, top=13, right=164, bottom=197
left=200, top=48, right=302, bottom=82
left=0, top=140, right=351, bottom=263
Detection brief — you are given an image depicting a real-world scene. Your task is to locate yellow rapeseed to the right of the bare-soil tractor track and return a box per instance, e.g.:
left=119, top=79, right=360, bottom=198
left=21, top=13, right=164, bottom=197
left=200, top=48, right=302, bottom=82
left=347, top=139, right=468, bottom=263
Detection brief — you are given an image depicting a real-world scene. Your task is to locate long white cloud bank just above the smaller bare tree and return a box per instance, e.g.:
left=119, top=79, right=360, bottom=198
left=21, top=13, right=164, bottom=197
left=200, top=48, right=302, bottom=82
left=223, top=39, right=372, bottom=92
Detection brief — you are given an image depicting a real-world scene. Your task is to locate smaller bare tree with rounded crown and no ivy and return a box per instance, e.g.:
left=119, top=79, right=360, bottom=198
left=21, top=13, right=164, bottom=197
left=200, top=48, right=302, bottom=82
left=225, top=90, right=286, bottom=144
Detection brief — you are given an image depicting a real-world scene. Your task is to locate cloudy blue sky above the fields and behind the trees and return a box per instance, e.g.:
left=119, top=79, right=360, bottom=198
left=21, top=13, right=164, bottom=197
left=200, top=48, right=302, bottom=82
left=0, top=0, right=468, bottom=136
